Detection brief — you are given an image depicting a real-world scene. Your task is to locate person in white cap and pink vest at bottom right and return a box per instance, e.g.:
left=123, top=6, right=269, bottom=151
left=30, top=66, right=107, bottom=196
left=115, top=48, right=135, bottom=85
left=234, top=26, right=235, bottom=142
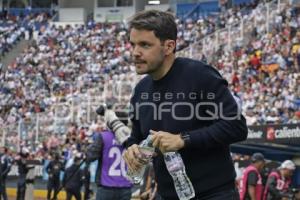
left=263, top=160, right=296, bottom=200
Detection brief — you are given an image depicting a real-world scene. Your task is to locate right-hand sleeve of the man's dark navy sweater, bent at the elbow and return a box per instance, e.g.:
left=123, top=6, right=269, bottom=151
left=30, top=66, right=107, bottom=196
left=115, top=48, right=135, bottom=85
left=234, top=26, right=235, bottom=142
left=189, top=66, right=248, bottom=149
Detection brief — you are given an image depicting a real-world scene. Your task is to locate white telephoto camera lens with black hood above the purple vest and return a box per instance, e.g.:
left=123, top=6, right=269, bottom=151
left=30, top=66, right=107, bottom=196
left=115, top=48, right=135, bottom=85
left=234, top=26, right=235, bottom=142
left=96, top=105, right=131, bottom=144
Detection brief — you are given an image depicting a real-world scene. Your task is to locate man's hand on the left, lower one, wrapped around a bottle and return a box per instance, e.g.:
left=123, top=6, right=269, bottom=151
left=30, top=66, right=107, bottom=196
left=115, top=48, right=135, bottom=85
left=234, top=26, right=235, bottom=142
left=123, top=144, right=148, bottom=171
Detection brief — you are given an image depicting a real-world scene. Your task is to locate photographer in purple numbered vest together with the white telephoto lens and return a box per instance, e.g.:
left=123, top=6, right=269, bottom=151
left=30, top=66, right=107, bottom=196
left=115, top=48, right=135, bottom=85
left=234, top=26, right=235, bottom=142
left=86, top=106, right=132, bottom=200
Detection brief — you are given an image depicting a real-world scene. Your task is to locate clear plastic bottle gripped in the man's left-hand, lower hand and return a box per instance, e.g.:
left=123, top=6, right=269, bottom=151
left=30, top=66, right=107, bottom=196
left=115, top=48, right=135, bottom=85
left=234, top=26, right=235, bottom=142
left=127, top=135, right=155, bottom=184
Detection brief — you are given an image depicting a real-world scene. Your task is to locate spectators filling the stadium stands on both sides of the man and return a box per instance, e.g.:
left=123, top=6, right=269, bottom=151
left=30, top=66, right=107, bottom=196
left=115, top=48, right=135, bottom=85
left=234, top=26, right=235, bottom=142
left=0, top=0, right=300, bottom=162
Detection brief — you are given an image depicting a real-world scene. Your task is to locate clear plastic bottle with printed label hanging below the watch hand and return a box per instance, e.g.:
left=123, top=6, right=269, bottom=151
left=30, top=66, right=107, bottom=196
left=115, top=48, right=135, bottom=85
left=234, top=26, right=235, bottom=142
left=164, top=152, right=195, bottom=200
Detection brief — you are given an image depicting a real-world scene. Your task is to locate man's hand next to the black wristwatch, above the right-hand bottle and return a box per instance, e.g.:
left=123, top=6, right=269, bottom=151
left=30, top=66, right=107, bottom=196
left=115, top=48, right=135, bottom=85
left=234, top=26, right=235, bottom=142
left=150, top=130, right=184, bottom=153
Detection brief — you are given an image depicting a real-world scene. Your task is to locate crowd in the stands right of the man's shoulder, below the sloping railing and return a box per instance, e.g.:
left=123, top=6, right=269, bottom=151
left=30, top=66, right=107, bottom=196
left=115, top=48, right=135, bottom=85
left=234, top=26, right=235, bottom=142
left=213, top=2, right=300, bottom=125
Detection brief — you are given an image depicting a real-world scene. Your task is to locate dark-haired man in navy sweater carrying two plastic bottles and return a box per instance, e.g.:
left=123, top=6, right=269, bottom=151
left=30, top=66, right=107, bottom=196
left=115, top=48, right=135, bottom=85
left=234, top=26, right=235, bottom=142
left=124, top=10, right=247, bottom=200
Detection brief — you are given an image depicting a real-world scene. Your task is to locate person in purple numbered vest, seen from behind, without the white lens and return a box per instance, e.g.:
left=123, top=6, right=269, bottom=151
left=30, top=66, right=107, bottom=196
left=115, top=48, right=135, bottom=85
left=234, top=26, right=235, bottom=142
left=86, top=131, right=132, bottom=200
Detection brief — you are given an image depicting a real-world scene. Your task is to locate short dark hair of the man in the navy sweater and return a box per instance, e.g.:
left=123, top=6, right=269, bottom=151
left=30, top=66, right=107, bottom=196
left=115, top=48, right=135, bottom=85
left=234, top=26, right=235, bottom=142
left=129, top=10, right=177, bottom=50
